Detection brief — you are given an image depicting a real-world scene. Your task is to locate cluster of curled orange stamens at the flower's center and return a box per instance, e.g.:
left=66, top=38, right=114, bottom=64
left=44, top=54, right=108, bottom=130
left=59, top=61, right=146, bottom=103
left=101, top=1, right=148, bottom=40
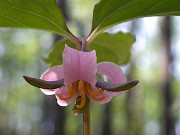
left=57, top=81, right=106, bottom=109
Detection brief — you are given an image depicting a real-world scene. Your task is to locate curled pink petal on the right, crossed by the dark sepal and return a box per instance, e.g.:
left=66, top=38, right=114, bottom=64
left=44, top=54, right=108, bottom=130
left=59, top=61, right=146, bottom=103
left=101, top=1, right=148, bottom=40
left=97, top=62, right=126, bottom=96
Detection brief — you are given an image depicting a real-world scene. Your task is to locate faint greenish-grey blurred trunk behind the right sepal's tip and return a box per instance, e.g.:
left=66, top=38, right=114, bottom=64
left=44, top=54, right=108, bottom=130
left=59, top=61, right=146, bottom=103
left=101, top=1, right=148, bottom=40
left=124, top=20, right=144, bottom=135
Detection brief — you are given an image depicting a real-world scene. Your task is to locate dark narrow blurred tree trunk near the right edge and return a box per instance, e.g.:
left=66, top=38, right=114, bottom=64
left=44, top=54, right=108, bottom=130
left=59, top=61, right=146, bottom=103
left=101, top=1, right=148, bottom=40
left=162, top=17, right=175, bottom=135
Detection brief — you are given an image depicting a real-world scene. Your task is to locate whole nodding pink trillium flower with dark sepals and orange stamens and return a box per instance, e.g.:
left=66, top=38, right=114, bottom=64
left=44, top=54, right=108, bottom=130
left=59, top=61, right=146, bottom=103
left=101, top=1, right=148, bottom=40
left=24, top=46, right=138, bottom=108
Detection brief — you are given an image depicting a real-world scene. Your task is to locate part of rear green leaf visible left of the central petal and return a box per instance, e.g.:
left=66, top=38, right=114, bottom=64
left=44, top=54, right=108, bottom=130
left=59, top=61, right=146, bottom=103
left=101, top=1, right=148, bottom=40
left=45, top=39, right=76, bottom=66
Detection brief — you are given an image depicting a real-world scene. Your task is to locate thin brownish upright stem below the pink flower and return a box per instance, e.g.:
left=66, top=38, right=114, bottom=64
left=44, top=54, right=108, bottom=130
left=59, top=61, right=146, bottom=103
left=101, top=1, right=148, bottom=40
left=83, top=104, right=91, bottom=135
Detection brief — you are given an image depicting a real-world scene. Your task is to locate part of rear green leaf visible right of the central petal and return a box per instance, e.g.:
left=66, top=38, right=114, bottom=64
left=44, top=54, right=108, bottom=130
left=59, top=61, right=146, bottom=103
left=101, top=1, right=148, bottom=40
left=89, top=32, right=136, bottom=65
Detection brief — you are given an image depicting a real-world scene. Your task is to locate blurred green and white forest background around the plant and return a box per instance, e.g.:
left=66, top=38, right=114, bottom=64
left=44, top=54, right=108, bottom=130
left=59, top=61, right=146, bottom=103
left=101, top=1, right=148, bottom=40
left=0, top=0, right=180, bottom=135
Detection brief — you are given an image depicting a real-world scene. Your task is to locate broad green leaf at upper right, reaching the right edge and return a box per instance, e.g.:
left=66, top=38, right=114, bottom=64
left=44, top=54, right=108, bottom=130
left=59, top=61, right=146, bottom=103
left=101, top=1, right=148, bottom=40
left=88, top=0, right=180, bottom=42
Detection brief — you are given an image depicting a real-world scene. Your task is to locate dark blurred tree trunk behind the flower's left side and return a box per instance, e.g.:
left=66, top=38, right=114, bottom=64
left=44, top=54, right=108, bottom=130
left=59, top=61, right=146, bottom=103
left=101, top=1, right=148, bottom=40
left=43, top=0, right=68, bottom=135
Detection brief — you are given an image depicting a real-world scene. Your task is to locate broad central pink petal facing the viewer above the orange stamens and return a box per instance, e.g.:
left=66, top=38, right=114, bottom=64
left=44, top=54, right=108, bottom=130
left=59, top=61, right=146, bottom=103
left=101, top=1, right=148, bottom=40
left=63, top=46, right=97, bottom=87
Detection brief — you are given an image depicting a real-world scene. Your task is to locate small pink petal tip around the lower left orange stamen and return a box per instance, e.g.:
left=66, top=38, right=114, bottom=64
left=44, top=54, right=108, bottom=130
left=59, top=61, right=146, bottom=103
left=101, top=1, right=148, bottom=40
left=55, top=87, right=79, bottom=106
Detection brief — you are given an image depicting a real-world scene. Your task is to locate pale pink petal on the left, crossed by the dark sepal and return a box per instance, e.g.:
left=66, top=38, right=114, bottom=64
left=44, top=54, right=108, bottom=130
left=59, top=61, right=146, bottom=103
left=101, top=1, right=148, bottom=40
left=41, top=65, right=64, bottom=95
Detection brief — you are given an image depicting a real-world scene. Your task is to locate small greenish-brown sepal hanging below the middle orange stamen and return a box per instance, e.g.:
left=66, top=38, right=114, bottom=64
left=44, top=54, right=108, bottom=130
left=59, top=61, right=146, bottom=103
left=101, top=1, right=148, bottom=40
left=72, top=96, right=90, bottom=115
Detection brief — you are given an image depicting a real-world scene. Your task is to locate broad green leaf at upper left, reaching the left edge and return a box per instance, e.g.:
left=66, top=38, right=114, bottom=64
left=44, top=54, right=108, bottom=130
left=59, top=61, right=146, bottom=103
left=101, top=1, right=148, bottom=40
left=0, top=0, right=77, bottom=42
